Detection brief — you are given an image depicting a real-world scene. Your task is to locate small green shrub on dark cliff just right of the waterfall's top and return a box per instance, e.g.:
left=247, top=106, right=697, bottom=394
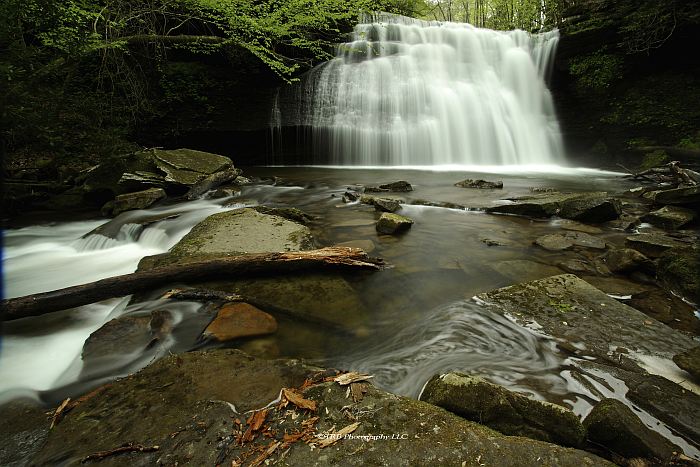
left=569, top=50, right=623, bottom=92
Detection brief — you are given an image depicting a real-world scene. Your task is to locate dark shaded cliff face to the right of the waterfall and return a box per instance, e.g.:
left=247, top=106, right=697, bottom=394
left=551, top=0, right=700, bottom=165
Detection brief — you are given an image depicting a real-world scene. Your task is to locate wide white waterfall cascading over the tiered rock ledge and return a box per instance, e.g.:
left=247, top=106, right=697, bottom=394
left=274, top=14, right=563, bottom=166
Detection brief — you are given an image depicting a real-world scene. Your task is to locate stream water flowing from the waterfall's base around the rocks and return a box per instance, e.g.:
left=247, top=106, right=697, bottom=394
left=0, top=167, right=697, bottom=455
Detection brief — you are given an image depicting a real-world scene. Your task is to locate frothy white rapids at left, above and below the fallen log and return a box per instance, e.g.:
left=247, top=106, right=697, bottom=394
left=0, top=200, right=237, bottom=403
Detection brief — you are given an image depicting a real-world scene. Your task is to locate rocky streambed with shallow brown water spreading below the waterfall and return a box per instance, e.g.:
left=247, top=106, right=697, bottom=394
left=0, top=153, right=700, bottom=465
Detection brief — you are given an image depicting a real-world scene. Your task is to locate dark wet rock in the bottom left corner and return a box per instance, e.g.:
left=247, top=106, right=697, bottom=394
left=0, top=400, right=51, bottom=467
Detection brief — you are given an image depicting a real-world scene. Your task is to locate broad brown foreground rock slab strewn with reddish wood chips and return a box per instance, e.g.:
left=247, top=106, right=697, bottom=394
left=33, top=350, right=612, bottom=467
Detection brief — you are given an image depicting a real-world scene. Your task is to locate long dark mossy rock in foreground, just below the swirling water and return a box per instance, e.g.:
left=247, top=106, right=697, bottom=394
left=420, top=373, right=586, bottom=447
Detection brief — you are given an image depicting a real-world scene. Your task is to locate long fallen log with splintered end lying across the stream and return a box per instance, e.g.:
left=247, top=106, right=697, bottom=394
left=0, top=247, right=383, bottom=321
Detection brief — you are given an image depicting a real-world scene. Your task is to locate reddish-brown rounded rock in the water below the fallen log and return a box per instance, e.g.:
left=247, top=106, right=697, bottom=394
left=202, top=303, right=277, bottom=342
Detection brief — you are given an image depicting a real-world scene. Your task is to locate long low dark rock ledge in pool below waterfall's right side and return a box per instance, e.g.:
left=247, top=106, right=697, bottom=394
left=486, top=192, right=621, bottom=223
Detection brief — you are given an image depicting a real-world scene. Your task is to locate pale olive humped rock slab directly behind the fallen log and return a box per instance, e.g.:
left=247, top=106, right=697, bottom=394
left=170, top=208, right=313, bottom=257
